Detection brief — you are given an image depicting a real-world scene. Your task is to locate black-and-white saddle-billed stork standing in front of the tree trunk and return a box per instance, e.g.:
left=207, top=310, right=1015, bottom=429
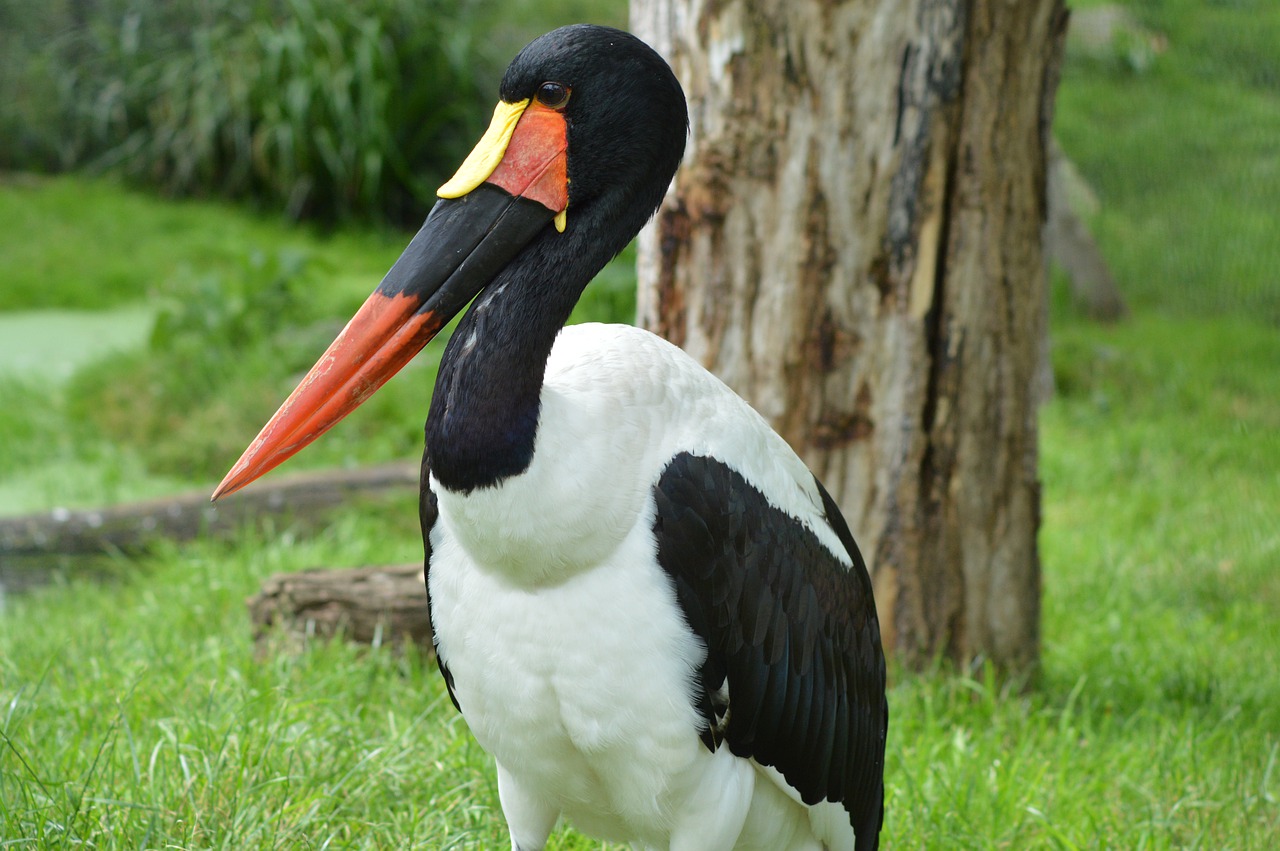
left=214, top=24, right=888, bottom=851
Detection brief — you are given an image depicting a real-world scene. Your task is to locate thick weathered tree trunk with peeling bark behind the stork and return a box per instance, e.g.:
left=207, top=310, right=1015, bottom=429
left=632, top=0, right=1066, bottom=668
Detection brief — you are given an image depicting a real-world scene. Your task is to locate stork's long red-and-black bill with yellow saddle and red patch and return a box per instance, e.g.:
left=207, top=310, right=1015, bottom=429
left=212, top=101, right=568, bottom=499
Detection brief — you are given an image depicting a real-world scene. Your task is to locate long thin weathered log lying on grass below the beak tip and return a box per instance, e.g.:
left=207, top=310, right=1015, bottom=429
left=0, top=463, right=419, bottom=558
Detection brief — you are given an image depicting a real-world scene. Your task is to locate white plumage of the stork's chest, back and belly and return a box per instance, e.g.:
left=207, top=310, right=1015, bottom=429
left=429, top=325, right=854, bottom=851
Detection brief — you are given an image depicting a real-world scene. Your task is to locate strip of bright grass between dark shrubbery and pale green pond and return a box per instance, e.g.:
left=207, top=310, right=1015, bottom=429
left=0, top=175, right=404, bottom=311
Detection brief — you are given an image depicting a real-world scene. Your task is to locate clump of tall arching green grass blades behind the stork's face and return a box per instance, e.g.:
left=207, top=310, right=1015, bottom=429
left=104, top=0, right=479, bottom=219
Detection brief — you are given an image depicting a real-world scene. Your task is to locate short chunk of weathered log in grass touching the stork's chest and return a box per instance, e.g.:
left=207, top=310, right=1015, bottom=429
left=246, top=563, right=431, bottom=650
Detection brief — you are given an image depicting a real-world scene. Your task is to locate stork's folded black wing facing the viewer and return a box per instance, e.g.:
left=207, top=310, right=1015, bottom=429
left=654, top=453, right=888, bottom=850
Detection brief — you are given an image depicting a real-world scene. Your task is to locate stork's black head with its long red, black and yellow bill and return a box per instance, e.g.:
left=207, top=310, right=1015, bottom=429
left=214, top=24, right=689, bottom=499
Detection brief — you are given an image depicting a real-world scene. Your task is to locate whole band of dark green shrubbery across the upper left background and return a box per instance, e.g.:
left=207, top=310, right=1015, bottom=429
left=0, top=0, right=486, bottom=223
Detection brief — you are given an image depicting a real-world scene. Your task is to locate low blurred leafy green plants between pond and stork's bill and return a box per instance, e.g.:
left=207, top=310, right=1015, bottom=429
left=67, top=251, right=340, bottom=477
